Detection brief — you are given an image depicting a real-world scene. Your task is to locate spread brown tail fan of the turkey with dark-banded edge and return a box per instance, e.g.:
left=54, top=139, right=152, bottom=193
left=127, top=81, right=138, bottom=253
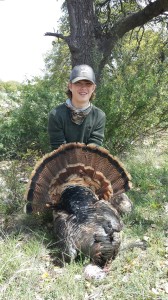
left=25, top=143, right=131, bottom=212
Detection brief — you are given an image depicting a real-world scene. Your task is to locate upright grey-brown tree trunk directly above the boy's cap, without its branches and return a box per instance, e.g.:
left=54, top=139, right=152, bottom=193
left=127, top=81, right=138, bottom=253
left=67, top=0, right=102, bottom=77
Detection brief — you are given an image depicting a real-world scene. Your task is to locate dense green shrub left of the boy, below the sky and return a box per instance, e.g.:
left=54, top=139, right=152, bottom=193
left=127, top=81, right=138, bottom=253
left=0, top=79, right=65, bottom=156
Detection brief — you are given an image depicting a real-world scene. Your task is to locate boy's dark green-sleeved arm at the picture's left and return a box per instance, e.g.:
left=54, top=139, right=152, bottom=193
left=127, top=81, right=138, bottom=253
left=48, top=109, right=66, bottom=150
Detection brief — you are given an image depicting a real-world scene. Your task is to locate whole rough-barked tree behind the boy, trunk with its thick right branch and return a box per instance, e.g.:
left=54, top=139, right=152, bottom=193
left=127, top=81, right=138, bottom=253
left=45, top=0, right=168, bottom=83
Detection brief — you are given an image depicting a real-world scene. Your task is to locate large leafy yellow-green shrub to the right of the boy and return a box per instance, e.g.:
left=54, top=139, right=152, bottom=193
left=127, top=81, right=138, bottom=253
left=96, top=31, right=168, bottom=153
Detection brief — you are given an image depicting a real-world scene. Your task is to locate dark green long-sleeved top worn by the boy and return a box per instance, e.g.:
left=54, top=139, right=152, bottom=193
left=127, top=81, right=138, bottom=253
left=48, top=103, right=106, bottom=150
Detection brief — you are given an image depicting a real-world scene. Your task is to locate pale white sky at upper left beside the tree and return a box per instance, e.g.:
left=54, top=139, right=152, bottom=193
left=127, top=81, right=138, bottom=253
left=0, top=0, right=63, bottom=82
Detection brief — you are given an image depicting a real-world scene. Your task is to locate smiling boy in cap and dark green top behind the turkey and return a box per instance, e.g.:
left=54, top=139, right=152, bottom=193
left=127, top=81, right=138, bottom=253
left=48, top=65, right=106, bottom=150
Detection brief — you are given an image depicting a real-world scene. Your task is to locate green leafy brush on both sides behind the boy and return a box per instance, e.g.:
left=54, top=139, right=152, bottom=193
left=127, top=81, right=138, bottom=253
left=0, top=29, right=168, bottom=156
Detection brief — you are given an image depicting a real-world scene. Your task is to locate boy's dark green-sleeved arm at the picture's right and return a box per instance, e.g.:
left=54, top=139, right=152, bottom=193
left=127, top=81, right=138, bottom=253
left=87, top=113, right=106, bottom=146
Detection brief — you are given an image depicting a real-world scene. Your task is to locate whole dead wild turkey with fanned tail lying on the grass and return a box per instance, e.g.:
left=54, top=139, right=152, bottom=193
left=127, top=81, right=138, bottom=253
left=26, top=143, right=131, bottom=267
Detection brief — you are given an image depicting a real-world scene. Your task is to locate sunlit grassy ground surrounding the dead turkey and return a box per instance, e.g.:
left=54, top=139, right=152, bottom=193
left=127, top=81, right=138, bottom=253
left=0, top=135, right=168, bottom=300
